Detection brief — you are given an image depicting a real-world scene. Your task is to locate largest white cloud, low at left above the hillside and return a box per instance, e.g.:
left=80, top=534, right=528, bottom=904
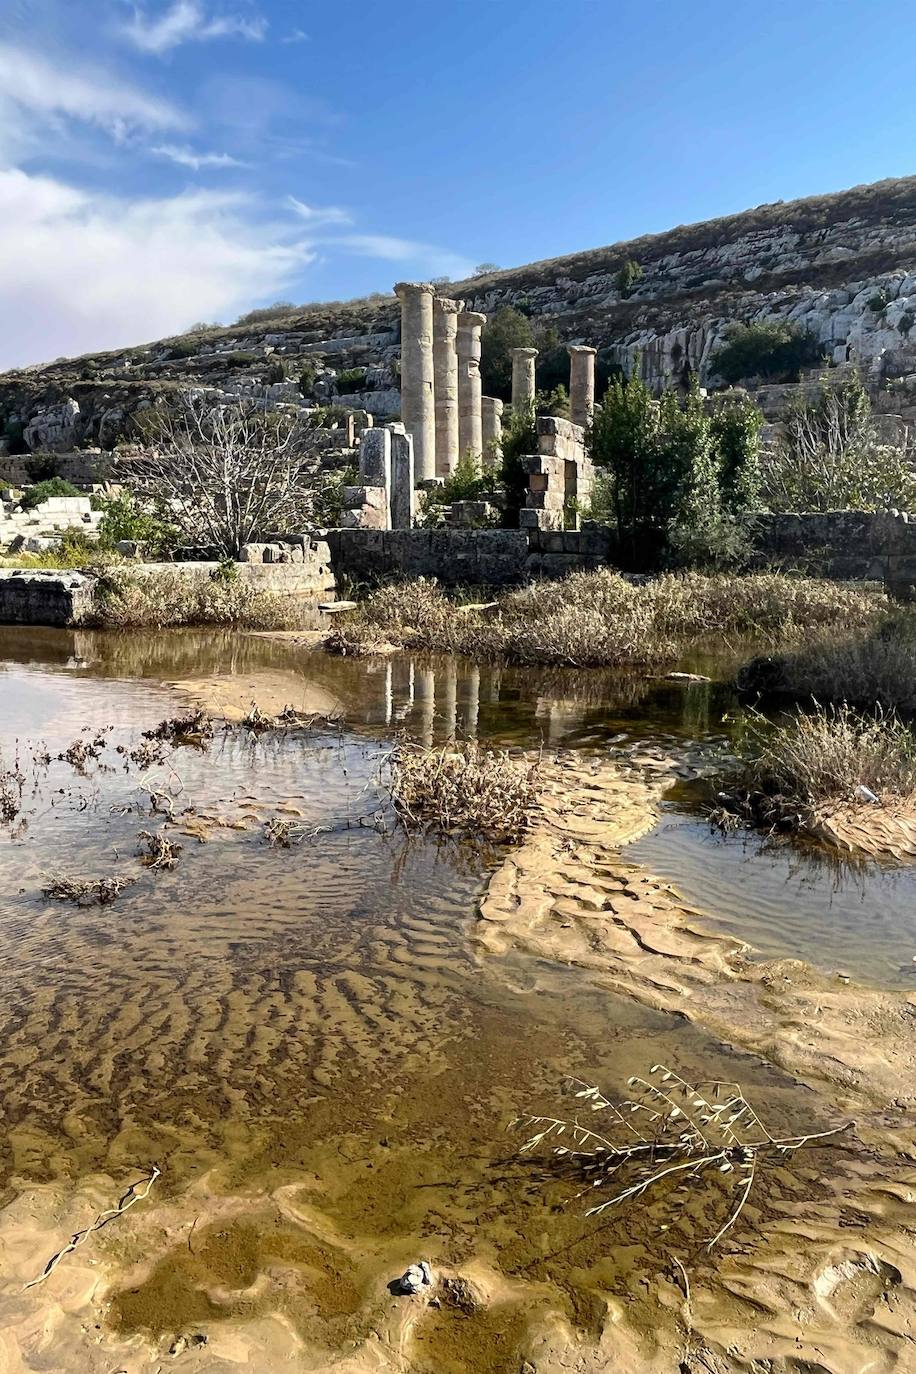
left=0, top=170, right=314, bottom=367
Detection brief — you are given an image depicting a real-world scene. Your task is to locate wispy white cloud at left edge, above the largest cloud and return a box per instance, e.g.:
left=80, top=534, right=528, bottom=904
left=0, top=41, right=185, bottom=155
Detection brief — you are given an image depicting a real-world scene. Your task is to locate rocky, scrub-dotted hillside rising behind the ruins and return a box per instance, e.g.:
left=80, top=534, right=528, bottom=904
left=0, top=177, right=916, bottom=451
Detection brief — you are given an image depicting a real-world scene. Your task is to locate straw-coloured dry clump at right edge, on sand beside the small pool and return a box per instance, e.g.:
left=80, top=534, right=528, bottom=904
left=713, top=705, right=916, bottom=830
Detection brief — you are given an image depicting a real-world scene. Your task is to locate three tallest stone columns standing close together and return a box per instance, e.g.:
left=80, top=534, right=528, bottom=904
left=394, top=282, right=492, bottom=482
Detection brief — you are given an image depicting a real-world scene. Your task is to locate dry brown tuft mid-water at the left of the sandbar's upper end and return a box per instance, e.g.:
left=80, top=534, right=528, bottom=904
left=387, top=741, right=540, bottom=844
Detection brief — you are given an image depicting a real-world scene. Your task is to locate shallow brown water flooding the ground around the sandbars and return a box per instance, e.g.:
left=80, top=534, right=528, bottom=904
left=0, top=629, right=912, bottom=1370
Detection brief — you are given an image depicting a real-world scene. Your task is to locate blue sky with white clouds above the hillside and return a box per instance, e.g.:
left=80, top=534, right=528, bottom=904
left=0, top=0, right=916, bottom=365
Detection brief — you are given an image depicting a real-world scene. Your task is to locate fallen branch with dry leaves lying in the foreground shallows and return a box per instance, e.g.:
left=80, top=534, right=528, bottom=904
left=512, top=1063, right=851, bottom=1250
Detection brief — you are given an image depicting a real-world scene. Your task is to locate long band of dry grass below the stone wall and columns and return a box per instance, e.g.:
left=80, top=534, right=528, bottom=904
left=328, top=569, right=886, bottom=668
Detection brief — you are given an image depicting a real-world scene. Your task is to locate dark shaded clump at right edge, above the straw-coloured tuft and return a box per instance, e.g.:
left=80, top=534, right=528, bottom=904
left=737, top=611, right=916, bottom=716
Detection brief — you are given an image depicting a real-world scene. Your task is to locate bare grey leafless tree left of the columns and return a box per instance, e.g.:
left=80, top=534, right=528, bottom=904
left=135, top=393, right=316, bottom=558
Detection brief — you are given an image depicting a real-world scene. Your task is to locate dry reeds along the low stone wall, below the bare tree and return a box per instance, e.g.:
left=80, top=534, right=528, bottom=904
left=91, top=569, right=304, bottom=629
